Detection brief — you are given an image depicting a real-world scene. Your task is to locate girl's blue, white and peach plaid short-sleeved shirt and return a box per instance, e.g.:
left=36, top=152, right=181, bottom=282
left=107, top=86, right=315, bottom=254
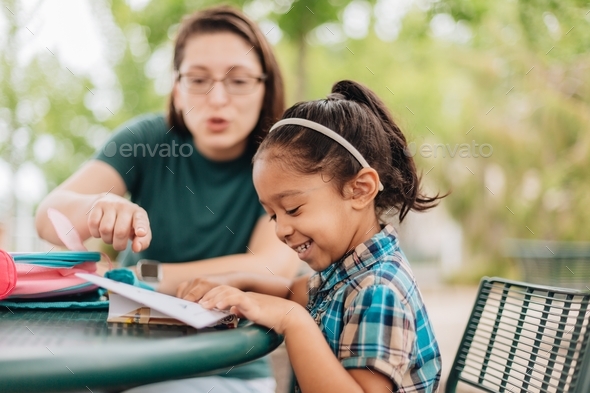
left=307, top=225, right=441, bottom=393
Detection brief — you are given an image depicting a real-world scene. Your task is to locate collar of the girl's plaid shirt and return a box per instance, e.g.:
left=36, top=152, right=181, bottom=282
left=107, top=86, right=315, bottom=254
left=309, top=224, right=399, bottom=297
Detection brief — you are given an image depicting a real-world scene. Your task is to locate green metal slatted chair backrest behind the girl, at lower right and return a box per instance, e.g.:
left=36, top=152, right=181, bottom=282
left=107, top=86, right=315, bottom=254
left=445, top=277, right=590, bottom=393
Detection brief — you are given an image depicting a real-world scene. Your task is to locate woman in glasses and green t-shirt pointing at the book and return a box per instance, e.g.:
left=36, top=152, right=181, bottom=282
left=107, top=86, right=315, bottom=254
left=36, top=7, right=297, bottom=392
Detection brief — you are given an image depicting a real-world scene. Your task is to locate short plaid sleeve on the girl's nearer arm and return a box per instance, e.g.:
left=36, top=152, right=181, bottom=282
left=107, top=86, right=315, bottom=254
left=338, top=285, right=416, bottom=386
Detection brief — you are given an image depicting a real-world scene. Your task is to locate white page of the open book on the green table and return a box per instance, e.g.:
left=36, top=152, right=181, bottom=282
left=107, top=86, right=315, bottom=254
left=76, top=273, right=229, bottom=329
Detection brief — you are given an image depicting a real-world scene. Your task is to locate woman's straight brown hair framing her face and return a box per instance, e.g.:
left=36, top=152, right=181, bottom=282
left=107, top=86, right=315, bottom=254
left=168, top=6, right=285, bottom=151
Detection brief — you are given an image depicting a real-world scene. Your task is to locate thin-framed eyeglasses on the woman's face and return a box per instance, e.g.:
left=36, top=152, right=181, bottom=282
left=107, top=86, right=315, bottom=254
left=178, top=74, right=266, bottom=95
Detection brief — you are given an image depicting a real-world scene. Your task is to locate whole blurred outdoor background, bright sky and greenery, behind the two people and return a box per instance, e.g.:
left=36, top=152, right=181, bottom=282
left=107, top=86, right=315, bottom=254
left=0, top=0, right=590, bottom=285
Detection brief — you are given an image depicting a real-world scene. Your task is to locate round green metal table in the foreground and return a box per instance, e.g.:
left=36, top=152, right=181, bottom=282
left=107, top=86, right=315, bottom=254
left=0, top=307, right=282, bottom=393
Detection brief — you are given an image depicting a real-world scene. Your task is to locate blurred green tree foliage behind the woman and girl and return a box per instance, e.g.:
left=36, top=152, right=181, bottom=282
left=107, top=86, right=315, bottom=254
left=0, top=0, right=590, bottom=272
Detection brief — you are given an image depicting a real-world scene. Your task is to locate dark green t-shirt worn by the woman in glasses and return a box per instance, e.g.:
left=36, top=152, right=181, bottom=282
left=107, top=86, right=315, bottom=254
left=96, top=115, right=264, bottom=266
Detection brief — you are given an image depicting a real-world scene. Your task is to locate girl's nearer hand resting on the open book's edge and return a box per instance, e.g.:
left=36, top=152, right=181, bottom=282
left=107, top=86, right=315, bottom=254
left=199, top=285, right=309, bottom=334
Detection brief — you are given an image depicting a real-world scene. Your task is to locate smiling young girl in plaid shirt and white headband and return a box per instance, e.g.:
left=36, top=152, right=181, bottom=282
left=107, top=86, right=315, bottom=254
left=178, top=81, right=441, bottom=393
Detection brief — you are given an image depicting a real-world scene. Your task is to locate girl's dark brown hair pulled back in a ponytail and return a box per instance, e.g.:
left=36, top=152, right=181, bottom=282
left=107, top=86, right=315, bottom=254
left=254, top=80, right=446, bottom=222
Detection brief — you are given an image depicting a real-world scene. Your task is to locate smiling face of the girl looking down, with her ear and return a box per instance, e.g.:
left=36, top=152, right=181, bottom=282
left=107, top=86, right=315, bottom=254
left=253, top=154, right=379, bottom=271
